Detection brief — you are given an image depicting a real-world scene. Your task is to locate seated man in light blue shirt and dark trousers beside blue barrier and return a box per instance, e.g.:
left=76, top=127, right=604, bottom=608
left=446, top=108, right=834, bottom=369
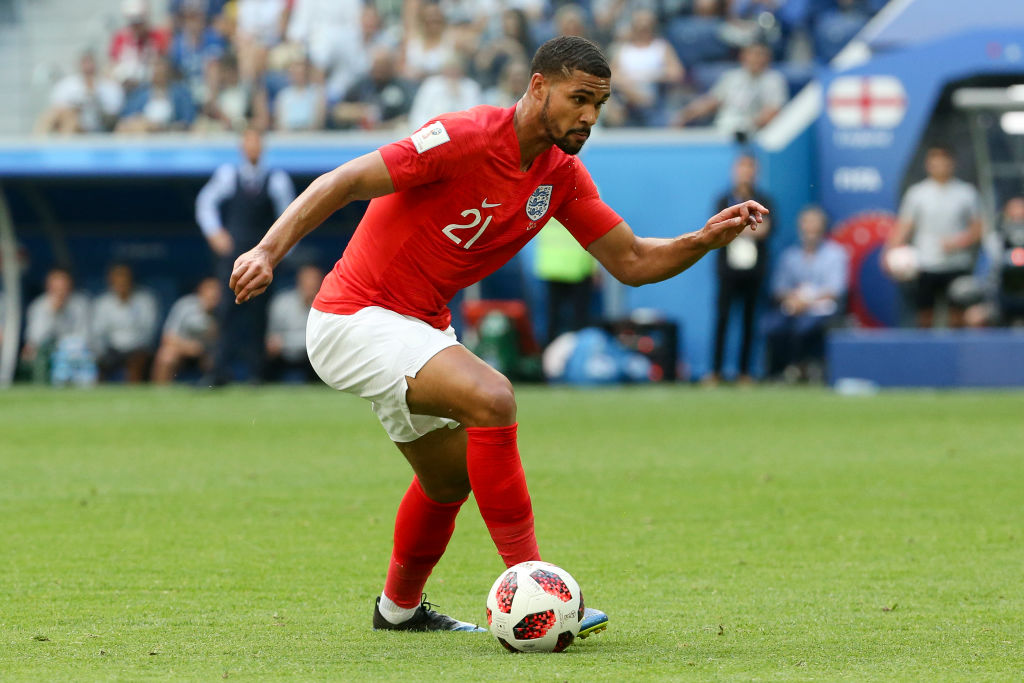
left=764, top=207, right=849, bottom=381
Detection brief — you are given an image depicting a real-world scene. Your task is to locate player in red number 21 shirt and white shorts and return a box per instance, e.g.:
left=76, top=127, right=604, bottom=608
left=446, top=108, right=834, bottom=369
left=230, top=37, right=767, bottom=637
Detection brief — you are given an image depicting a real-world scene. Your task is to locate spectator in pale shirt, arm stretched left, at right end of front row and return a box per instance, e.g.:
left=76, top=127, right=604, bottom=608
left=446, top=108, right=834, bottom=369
left=679, top=43, right=787, bottom=137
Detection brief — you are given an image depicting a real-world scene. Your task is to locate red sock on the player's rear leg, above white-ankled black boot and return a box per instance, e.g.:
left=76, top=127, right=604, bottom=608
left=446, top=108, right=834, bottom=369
left=384, top=477, right=466, bottom=608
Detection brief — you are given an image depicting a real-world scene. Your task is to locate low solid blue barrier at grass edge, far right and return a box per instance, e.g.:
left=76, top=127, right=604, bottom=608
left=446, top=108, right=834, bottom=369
left=825, top=329, right=1024, bottom=388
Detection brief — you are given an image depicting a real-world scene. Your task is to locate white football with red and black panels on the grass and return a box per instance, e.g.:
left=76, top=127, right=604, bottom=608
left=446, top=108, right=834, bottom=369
left=487, top=561, right=584, bottom=652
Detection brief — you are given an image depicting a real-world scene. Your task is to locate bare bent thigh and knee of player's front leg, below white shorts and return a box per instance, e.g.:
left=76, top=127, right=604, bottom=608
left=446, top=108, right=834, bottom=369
left=406, top=346, right=516, bottom=427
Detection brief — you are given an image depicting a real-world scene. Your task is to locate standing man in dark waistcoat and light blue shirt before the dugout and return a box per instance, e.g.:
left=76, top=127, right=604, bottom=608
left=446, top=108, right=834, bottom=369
left=196, top=128, right=295, bottom=386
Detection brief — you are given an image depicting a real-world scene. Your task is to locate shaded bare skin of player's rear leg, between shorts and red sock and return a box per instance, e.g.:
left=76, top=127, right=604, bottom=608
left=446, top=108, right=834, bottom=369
left=395, top=427, right=470, bottom=503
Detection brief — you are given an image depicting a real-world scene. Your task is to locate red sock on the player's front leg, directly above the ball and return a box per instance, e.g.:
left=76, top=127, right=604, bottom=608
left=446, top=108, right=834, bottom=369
left=466, top=424, right=541, bottom=566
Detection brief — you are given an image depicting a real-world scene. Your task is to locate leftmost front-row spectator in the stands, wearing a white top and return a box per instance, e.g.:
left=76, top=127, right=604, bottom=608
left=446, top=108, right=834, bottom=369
left=36, top=52, right=125, bottom=135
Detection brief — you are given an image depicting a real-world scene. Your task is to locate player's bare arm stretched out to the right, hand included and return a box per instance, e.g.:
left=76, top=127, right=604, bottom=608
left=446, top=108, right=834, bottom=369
left=587, top=200, right=768, bottom=287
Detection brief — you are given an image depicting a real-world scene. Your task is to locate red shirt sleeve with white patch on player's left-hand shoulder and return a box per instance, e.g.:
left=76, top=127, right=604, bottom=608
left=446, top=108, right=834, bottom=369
left=380, top=118, right=488, bottom=191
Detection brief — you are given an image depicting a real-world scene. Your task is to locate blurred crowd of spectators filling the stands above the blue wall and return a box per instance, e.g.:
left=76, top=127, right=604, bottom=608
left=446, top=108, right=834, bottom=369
left=36, top=0, right=886, bottom=134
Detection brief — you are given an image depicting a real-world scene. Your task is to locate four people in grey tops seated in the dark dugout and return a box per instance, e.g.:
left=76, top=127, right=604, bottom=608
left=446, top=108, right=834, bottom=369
left=9, top=263, right=324, bottom=385
